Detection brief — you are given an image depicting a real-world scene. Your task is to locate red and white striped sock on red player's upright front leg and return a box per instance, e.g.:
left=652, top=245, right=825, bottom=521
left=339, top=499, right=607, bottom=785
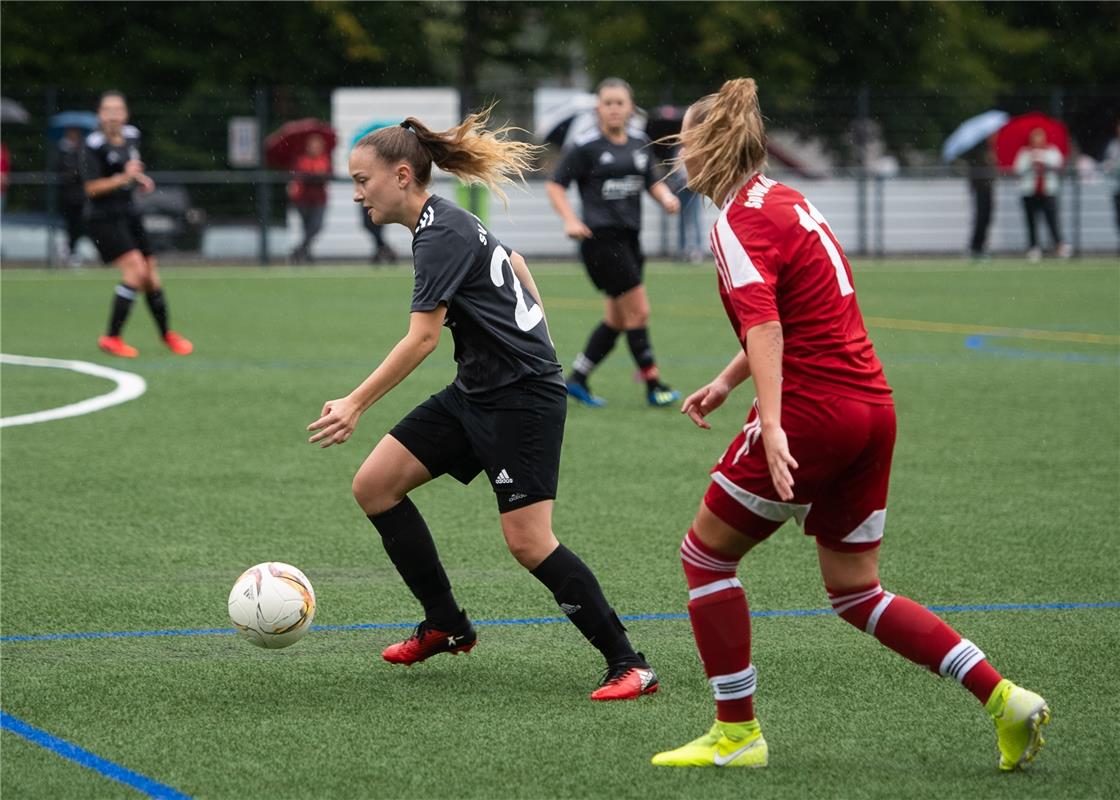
left=681, top=530, right=756, bottom=723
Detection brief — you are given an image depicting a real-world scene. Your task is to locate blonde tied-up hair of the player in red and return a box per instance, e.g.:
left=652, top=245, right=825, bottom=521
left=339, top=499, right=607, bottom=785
left=675, top=77, right=766, bottom=203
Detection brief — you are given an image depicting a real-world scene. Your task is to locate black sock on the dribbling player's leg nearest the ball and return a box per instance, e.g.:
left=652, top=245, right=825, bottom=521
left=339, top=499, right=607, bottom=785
left=370, top=497, right=466, bottom=631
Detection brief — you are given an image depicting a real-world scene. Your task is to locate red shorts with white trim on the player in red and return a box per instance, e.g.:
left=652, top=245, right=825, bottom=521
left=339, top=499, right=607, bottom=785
left=703, top=393, right=895, bottom=552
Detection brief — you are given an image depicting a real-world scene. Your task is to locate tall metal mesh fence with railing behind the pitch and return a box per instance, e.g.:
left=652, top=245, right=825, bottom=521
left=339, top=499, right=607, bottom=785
left=0, top=82, right=1120, bottom=264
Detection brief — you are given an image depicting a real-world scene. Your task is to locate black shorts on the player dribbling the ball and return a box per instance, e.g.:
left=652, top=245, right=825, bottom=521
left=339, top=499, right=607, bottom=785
left=389, top=380, right=568, bottom=513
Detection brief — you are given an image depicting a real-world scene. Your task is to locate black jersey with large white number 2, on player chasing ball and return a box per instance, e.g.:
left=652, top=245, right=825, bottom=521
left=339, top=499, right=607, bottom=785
left=412, top=195, right=561, bottom=394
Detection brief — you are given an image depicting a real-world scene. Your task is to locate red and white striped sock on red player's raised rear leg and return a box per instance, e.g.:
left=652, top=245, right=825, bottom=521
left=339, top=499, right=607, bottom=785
left=828, top=584, right=1002, bottom=703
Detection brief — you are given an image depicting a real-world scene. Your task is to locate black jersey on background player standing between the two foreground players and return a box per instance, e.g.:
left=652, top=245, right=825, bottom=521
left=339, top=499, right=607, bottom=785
left=552, top=130, right=656, bottom=231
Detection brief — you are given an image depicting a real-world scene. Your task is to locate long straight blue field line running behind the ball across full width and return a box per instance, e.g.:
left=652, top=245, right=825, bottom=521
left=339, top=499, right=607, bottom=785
left=0, top=601, right=1120, bottom=644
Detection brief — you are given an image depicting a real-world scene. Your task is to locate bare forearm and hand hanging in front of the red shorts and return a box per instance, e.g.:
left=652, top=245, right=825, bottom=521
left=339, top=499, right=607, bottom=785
left=747, top=320, right=797, bottom=501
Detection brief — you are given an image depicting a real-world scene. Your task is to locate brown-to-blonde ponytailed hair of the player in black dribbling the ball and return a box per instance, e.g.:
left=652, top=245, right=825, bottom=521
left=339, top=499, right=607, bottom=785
left=354, top=104, right=543, bottom=203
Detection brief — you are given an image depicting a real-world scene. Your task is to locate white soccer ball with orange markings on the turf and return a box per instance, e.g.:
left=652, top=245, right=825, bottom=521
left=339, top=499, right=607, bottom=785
left=230, top=561, right=315, bottom=650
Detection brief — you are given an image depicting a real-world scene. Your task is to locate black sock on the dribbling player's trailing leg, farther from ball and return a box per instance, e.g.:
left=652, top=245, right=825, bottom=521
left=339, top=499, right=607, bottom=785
left=532, top=545, right=637, bottom=662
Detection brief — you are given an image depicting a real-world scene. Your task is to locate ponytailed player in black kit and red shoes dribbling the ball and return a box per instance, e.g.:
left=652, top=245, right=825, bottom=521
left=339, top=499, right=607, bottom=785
left=308, top=112, right=657, bottom=700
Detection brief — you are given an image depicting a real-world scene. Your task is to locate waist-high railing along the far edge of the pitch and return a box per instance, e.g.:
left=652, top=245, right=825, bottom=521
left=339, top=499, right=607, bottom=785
left=0, top=168, right=1118, bottom=266
